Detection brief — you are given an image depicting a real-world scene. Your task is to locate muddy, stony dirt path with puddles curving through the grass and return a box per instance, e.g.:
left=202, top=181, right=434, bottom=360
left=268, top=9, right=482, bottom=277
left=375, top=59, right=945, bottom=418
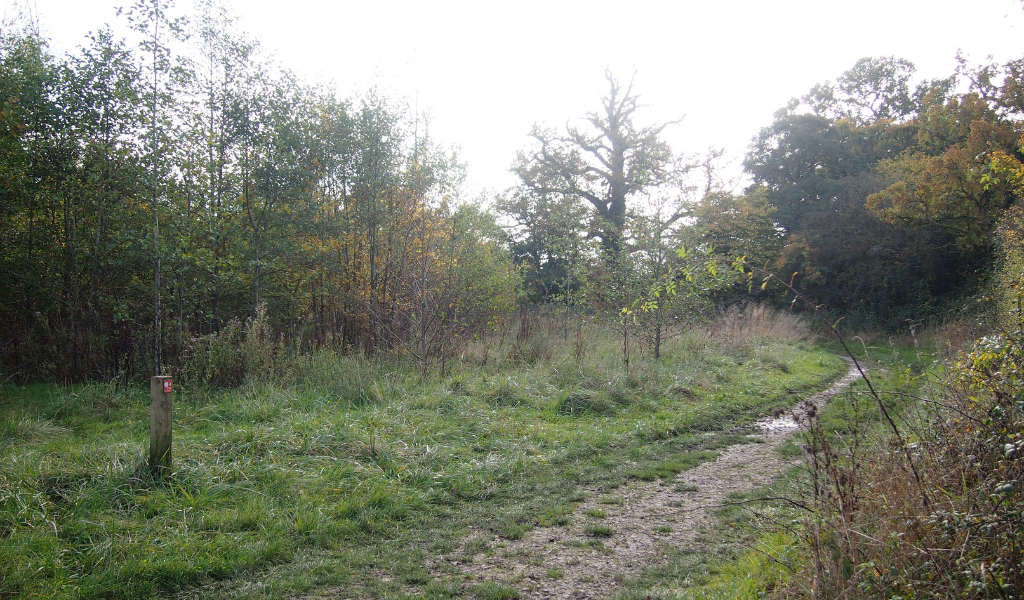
left=436, top=358, right=859, bottom=600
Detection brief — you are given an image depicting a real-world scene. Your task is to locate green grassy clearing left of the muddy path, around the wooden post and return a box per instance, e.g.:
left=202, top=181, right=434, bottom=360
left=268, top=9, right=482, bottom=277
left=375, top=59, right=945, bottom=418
left=0, top=317, right=845, bottom=598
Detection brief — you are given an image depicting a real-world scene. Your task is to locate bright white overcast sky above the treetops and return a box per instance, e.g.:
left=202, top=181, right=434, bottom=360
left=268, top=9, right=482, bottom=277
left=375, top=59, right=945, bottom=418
left=6, top=0, right=1024, bottom=197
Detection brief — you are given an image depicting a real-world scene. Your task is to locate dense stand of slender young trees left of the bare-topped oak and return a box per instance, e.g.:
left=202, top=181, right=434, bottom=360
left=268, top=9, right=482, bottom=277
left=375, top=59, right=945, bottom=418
left=0, top=5, right=518, bottom=381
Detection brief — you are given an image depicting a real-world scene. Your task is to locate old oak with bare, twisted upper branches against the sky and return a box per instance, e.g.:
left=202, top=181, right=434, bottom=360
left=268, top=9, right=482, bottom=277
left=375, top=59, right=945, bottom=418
left=513, top=71, right=679, bottom=262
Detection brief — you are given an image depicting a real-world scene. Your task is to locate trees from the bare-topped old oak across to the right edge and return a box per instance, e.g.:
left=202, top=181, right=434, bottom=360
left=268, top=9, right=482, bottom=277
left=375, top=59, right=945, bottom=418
left=502, top=57, right=1024, bottom=331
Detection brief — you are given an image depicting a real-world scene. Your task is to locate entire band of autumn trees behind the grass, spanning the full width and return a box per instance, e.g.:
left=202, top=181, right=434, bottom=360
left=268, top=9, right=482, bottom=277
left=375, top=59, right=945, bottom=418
left=0, top=2, right=1024, bottom=381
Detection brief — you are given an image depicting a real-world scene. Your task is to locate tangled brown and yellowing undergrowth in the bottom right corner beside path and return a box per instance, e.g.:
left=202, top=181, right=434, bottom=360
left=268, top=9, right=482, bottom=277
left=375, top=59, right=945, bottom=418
left=784, top=330, right=1024, bottom=598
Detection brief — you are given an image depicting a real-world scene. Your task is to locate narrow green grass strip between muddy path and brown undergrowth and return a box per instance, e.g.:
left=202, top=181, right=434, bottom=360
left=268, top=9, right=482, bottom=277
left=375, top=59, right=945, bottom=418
left=606, top=333, right=941, bottom=600
